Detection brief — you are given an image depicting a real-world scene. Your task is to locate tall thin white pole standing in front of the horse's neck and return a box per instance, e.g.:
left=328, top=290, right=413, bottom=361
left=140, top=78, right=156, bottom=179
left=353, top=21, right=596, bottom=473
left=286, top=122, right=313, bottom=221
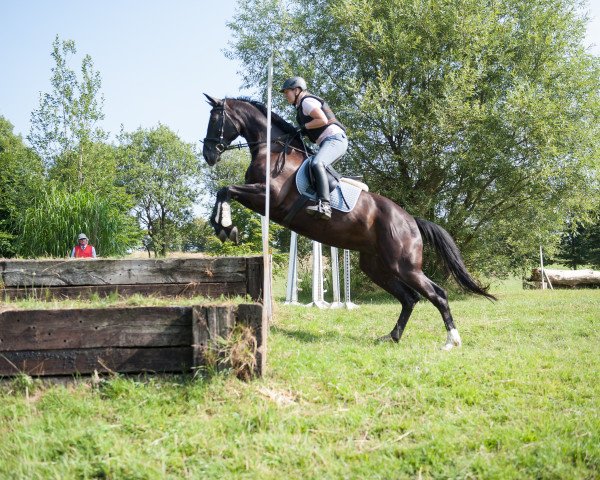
left=262, top=53, right=273, bottom=321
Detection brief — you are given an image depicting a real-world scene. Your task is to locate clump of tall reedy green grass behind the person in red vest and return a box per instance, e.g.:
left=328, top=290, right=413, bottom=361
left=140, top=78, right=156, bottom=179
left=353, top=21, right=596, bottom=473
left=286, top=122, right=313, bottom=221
left=18, top=187, right=140, bottom=257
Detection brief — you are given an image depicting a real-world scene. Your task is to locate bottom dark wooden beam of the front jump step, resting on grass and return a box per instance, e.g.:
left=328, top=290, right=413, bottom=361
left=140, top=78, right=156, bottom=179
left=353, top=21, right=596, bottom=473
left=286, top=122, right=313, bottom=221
left=0, top=347, right=192, bottom=376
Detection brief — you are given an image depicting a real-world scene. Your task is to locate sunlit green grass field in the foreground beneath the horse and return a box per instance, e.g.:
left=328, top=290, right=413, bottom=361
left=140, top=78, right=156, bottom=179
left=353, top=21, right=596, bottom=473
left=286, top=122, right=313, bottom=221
left=0, top=283, right=600, bottom=479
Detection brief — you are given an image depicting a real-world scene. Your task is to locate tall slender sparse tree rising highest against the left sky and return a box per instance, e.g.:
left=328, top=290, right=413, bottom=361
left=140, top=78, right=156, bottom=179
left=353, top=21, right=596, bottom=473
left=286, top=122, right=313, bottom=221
left=27, top=36, right=109, bottom=191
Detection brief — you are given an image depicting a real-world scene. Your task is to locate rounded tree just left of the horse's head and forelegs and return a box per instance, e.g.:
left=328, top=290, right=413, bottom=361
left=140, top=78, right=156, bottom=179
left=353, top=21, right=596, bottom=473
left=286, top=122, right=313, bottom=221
left=119, top=124, right=198, bottom=256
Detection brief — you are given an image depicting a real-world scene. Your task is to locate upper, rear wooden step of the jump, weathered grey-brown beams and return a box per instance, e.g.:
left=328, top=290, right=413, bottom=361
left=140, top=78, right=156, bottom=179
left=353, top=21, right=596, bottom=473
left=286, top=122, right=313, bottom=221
left=0, top=256, right=263, bottom=301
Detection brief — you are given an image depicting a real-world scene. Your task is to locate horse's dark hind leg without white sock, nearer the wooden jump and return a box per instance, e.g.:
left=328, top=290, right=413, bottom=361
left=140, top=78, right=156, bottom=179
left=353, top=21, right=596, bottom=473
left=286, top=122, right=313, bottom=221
left=360, top=253, right=419, bottom=342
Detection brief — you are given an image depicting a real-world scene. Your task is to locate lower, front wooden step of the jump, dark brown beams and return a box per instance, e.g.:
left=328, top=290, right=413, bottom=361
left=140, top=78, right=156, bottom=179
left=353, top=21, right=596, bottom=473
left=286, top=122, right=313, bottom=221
left=0, top=304, right=267, bottom=376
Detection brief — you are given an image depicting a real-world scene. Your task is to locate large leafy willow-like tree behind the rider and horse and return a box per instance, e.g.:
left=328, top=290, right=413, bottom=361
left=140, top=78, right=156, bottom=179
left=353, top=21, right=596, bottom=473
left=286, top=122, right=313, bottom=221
left=228, top=0, right=600, bottom=272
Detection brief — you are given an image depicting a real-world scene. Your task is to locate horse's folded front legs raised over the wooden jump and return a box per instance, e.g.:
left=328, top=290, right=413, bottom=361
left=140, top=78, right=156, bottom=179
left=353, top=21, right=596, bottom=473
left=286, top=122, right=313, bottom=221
left=210, top=183, right=265, bottom=244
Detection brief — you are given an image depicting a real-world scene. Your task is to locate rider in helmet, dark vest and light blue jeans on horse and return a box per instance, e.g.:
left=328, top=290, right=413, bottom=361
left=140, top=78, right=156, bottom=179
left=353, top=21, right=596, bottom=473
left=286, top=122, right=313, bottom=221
left=281, top=77, right=348, bottom=220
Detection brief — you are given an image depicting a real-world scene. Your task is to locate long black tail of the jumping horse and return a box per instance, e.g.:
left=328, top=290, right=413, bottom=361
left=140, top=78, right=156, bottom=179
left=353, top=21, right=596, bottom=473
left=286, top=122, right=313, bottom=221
left=415, top=217, right=497, bottom=300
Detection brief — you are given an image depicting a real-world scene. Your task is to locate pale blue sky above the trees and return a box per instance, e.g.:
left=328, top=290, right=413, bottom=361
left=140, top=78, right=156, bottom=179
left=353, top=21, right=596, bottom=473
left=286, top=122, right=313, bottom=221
left=0, top=0, right=600, bottom=144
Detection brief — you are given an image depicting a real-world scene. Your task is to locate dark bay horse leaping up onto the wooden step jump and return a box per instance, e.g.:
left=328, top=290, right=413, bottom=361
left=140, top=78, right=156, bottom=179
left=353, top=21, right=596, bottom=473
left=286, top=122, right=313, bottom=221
left=202, top=95, right=495, bottom=350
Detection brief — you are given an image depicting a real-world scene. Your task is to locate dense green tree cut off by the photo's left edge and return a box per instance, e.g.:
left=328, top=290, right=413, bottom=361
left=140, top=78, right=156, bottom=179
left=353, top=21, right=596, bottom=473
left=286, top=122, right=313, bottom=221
left=0, top=116, right=45, bottom=257
